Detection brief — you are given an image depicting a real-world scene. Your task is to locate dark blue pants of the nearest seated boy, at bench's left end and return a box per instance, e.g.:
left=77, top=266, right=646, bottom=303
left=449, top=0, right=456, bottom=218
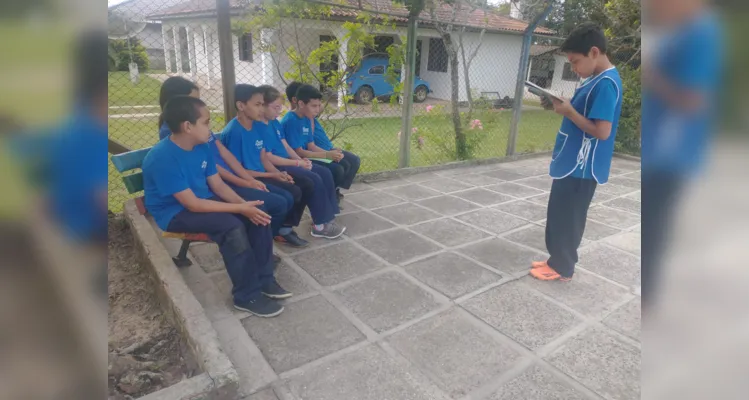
left=167, top=203, right=273, bottom=304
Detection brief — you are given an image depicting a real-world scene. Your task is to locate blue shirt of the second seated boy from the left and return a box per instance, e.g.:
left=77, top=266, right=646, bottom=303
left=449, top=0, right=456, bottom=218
left=221, top=118, right=265, bottom=172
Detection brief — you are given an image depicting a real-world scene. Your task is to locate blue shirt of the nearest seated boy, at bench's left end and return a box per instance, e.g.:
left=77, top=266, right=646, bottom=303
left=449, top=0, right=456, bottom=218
left=143, top=138, right=217, bottom=231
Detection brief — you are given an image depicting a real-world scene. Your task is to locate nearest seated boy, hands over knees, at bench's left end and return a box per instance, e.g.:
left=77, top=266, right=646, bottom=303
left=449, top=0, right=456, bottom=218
left=143, top=96, right=291, bottom=317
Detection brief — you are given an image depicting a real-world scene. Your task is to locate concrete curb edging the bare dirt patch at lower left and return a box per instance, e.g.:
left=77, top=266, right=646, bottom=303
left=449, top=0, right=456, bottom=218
left=125, top=200, right=239, bottom=400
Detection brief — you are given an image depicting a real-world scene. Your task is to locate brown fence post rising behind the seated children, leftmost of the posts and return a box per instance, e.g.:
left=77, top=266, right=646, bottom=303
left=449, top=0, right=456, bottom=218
left=216, top=0, right=236, bottom=122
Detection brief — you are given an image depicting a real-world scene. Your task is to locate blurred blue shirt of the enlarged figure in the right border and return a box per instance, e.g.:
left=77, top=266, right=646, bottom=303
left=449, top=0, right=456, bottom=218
left=642, top=12, right=725, bottom=174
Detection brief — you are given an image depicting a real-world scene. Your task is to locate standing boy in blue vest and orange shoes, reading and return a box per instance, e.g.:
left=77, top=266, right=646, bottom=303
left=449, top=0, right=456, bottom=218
left=531, top=23, right=622, bottom=281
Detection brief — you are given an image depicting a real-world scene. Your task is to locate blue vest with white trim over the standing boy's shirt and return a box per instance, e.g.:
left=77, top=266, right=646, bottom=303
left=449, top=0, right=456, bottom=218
left=549, top=67, right=622, bottom=184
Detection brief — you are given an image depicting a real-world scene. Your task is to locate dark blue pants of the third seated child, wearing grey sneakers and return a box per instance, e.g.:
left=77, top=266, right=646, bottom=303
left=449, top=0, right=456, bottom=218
left=280, top=165, right=340, bottom=225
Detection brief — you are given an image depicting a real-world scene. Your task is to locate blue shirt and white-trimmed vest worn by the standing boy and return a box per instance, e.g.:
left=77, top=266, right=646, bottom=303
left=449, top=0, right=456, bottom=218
left=549, top=67, right=623, bottom=184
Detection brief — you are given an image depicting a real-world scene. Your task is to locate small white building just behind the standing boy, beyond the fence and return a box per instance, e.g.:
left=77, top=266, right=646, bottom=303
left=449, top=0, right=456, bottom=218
left=525, top=45, right=580, bottom=98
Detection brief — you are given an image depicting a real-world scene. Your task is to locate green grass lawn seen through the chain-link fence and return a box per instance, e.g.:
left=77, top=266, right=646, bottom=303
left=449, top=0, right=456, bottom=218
left=109, top=111, right=561, bottom=212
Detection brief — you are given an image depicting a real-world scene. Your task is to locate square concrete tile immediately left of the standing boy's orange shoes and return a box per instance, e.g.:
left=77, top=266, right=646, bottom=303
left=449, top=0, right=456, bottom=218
left=460, top=238, right=546, bottom=274
